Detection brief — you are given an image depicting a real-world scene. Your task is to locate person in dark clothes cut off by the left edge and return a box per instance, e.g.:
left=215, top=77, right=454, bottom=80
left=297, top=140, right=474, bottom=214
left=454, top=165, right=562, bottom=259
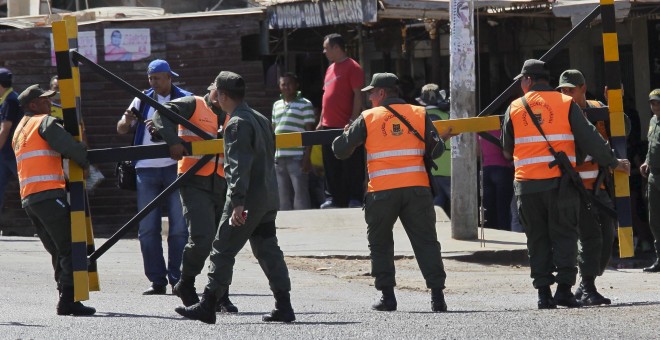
left=0, top=67, right=23, bottom=220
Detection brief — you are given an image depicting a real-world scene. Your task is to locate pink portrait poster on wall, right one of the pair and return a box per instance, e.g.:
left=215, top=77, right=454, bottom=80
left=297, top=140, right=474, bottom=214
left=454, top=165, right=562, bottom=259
left=103, top=28, right=151, bottom=61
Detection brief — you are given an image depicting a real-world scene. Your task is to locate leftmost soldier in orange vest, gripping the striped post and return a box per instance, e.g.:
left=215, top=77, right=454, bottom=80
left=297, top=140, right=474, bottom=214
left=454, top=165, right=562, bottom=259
left=12, top=84, right=96, bottom=315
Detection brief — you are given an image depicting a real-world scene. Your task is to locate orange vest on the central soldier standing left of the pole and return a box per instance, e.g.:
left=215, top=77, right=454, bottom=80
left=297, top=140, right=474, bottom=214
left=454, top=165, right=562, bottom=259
left=362, top=104, right=429, bottom=192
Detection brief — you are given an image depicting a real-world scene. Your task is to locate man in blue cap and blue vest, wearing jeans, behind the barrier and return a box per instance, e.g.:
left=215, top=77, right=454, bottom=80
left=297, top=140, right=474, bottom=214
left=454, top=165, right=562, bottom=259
left=117, top=59, right=192, bottom=295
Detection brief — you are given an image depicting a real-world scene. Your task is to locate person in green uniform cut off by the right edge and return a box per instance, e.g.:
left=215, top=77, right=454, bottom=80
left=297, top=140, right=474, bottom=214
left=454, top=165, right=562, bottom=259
left=639, top=89, right=660, bottom=273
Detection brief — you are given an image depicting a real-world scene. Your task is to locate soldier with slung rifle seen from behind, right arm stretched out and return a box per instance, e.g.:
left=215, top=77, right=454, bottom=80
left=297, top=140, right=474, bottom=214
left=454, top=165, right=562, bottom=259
left=502, top=59, right=630, bottom=309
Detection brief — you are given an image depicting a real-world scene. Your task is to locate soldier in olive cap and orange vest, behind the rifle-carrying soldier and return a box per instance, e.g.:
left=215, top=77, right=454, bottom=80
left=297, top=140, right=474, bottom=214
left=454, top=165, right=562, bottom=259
left=557, top=70, right=630, bottom=306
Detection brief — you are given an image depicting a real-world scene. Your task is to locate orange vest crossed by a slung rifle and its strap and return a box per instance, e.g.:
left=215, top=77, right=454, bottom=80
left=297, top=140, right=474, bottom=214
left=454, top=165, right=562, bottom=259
left=509, top=91, right=575, bottom=181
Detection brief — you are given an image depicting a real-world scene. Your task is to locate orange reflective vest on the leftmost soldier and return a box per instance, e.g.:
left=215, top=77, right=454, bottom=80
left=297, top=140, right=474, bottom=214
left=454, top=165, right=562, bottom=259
left=12, top=115, right=65, bottom=198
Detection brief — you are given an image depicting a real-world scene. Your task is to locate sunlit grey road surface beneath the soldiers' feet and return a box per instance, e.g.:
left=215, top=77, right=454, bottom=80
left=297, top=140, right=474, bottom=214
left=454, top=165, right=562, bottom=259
left=0, top=209, right=660, bottom=339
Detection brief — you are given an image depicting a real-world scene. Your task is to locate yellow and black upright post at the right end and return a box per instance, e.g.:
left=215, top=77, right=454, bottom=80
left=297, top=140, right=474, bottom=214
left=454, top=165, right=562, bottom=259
left=600, top=0, right=635, bottom=258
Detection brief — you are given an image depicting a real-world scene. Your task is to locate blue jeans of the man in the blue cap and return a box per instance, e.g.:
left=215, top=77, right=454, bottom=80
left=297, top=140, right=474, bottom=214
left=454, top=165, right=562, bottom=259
left=136, top=164, right=188, bottom=286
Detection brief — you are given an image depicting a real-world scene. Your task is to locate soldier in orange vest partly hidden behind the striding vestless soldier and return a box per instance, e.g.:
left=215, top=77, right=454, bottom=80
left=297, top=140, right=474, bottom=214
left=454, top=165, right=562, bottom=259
left=153, top=83, right=238, bottom=313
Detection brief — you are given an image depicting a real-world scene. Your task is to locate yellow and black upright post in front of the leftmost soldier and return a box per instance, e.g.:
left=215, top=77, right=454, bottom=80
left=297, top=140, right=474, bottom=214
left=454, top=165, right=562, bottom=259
left=52, top=17, right=99, bottom=301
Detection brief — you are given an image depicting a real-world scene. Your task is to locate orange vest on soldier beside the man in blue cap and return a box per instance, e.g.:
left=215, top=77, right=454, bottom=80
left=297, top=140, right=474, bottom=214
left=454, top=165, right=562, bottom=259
left=178, top=96, right=229, bottom=177
